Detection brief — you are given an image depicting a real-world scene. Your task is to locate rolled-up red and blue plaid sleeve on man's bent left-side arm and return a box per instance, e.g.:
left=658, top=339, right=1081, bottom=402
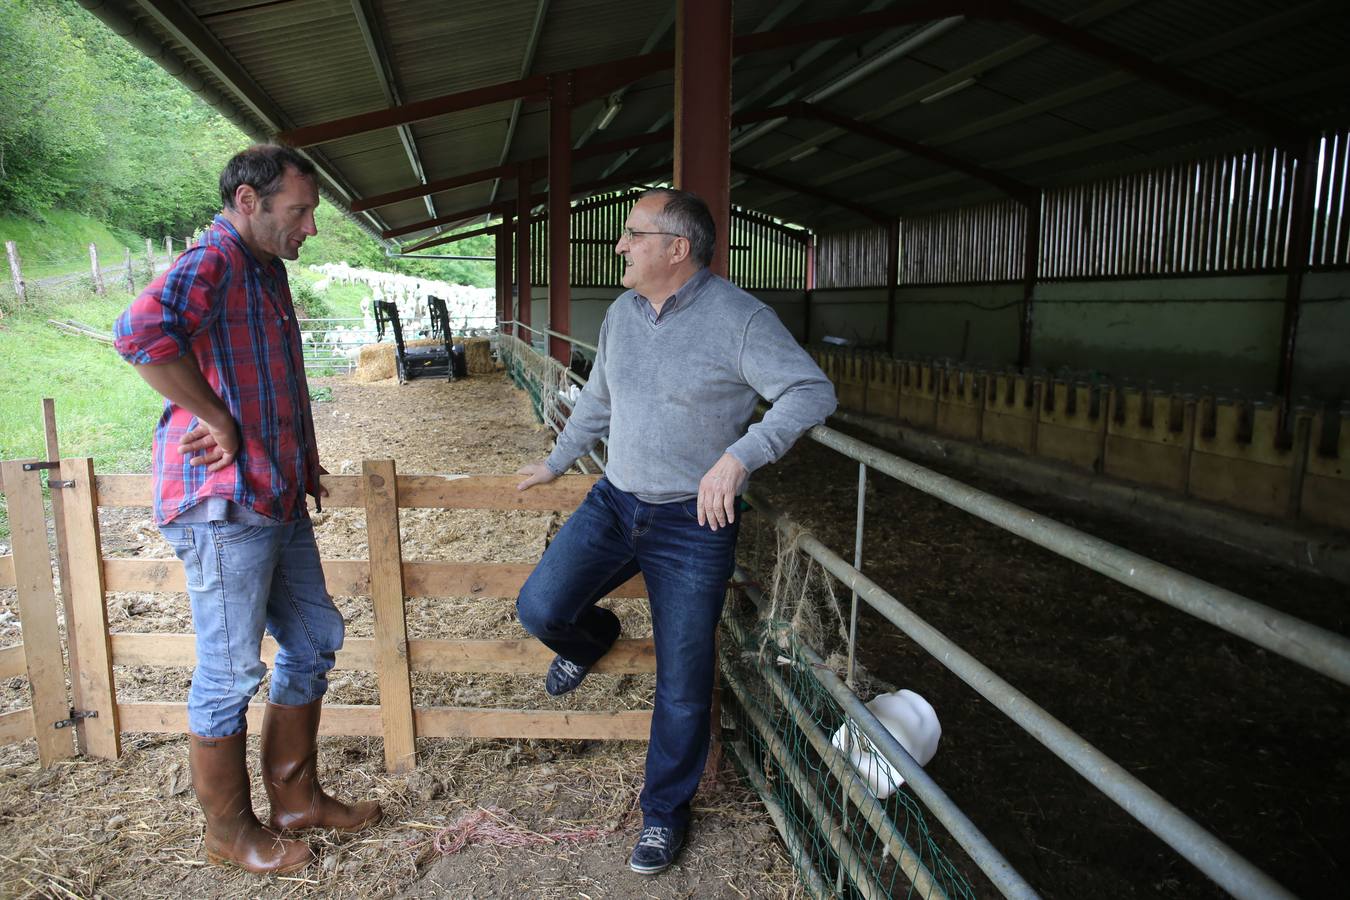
left=112, top=247, right=230, bottom=366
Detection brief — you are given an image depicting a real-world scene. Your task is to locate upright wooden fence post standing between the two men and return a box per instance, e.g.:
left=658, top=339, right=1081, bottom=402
left=360, top=459, right=417, bottom=772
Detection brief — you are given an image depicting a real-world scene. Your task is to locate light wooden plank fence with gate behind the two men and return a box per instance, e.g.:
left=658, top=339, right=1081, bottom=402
left=0, top=450, right=656, bottom=772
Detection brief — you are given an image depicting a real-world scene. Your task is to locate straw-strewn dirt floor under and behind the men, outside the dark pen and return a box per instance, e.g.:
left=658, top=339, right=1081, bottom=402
left=0, top=374, right=801, bottom=899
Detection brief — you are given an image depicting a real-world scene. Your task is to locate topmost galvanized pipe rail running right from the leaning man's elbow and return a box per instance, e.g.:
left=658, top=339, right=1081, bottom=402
left=809, top=425, right=1350, bottom=684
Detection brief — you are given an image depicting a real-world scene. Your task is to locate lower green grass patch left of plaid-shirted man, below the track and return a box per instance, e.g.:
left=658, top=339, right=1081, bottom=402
left=0, top=283, right=163, bottom=537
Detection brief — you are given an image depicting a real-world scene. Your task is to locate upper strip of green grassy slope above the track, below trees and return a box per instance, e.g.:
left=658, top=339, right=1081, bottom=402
left=0, top=209, right=145, bottom=285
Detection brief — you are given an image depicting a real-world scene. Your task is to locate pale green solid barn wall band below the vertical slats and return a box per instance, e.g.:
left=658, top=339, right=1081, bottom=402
left=533, top=271, right=1350, bottom=399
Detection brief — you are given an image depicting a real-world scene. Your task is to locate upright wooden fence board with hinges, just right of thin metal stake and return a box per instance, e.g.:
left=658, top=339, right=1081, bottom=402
left=61, top=459, right=122, bottom=760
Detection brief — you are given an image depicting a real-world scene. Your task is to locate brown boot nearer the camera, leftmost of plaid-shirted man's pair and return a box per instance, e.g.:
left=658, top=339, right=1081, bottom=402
left=188, top=731, right=315, bottom=874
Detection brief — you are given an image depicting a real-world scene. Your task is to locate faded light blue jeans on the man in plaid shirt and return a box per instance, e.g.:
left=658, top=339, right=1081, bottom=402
left=159, top=518, right=343, bottom=738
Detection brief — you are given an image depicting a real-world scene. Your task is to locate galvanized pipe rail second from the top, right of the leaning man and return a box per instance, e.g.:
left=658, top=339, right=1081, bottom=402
left=751, top=499, right=1293, bottom=900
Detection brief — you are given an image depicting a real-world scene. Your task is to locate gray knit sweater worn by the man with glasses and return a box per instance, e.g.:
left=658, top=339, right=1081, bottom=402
left=547, top=270, right=836, bottom=503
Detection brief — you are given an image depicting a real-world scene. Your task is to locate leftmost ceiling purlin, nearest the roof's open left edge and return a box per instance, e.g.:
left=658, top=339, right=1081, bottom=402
left=124, top=0, right=389, bottom=231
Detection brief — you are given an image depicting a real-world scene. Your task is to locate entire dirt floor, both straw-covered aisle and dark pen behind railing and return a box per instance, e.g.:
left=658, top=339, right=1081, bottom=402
left=0, top=375, right=1350, bottom=899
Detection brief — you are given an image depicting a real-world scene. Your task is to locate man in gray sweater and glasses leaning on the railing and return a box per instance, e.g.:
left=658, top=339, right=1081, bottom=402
left=516, top=190, right=836, bottom=874
